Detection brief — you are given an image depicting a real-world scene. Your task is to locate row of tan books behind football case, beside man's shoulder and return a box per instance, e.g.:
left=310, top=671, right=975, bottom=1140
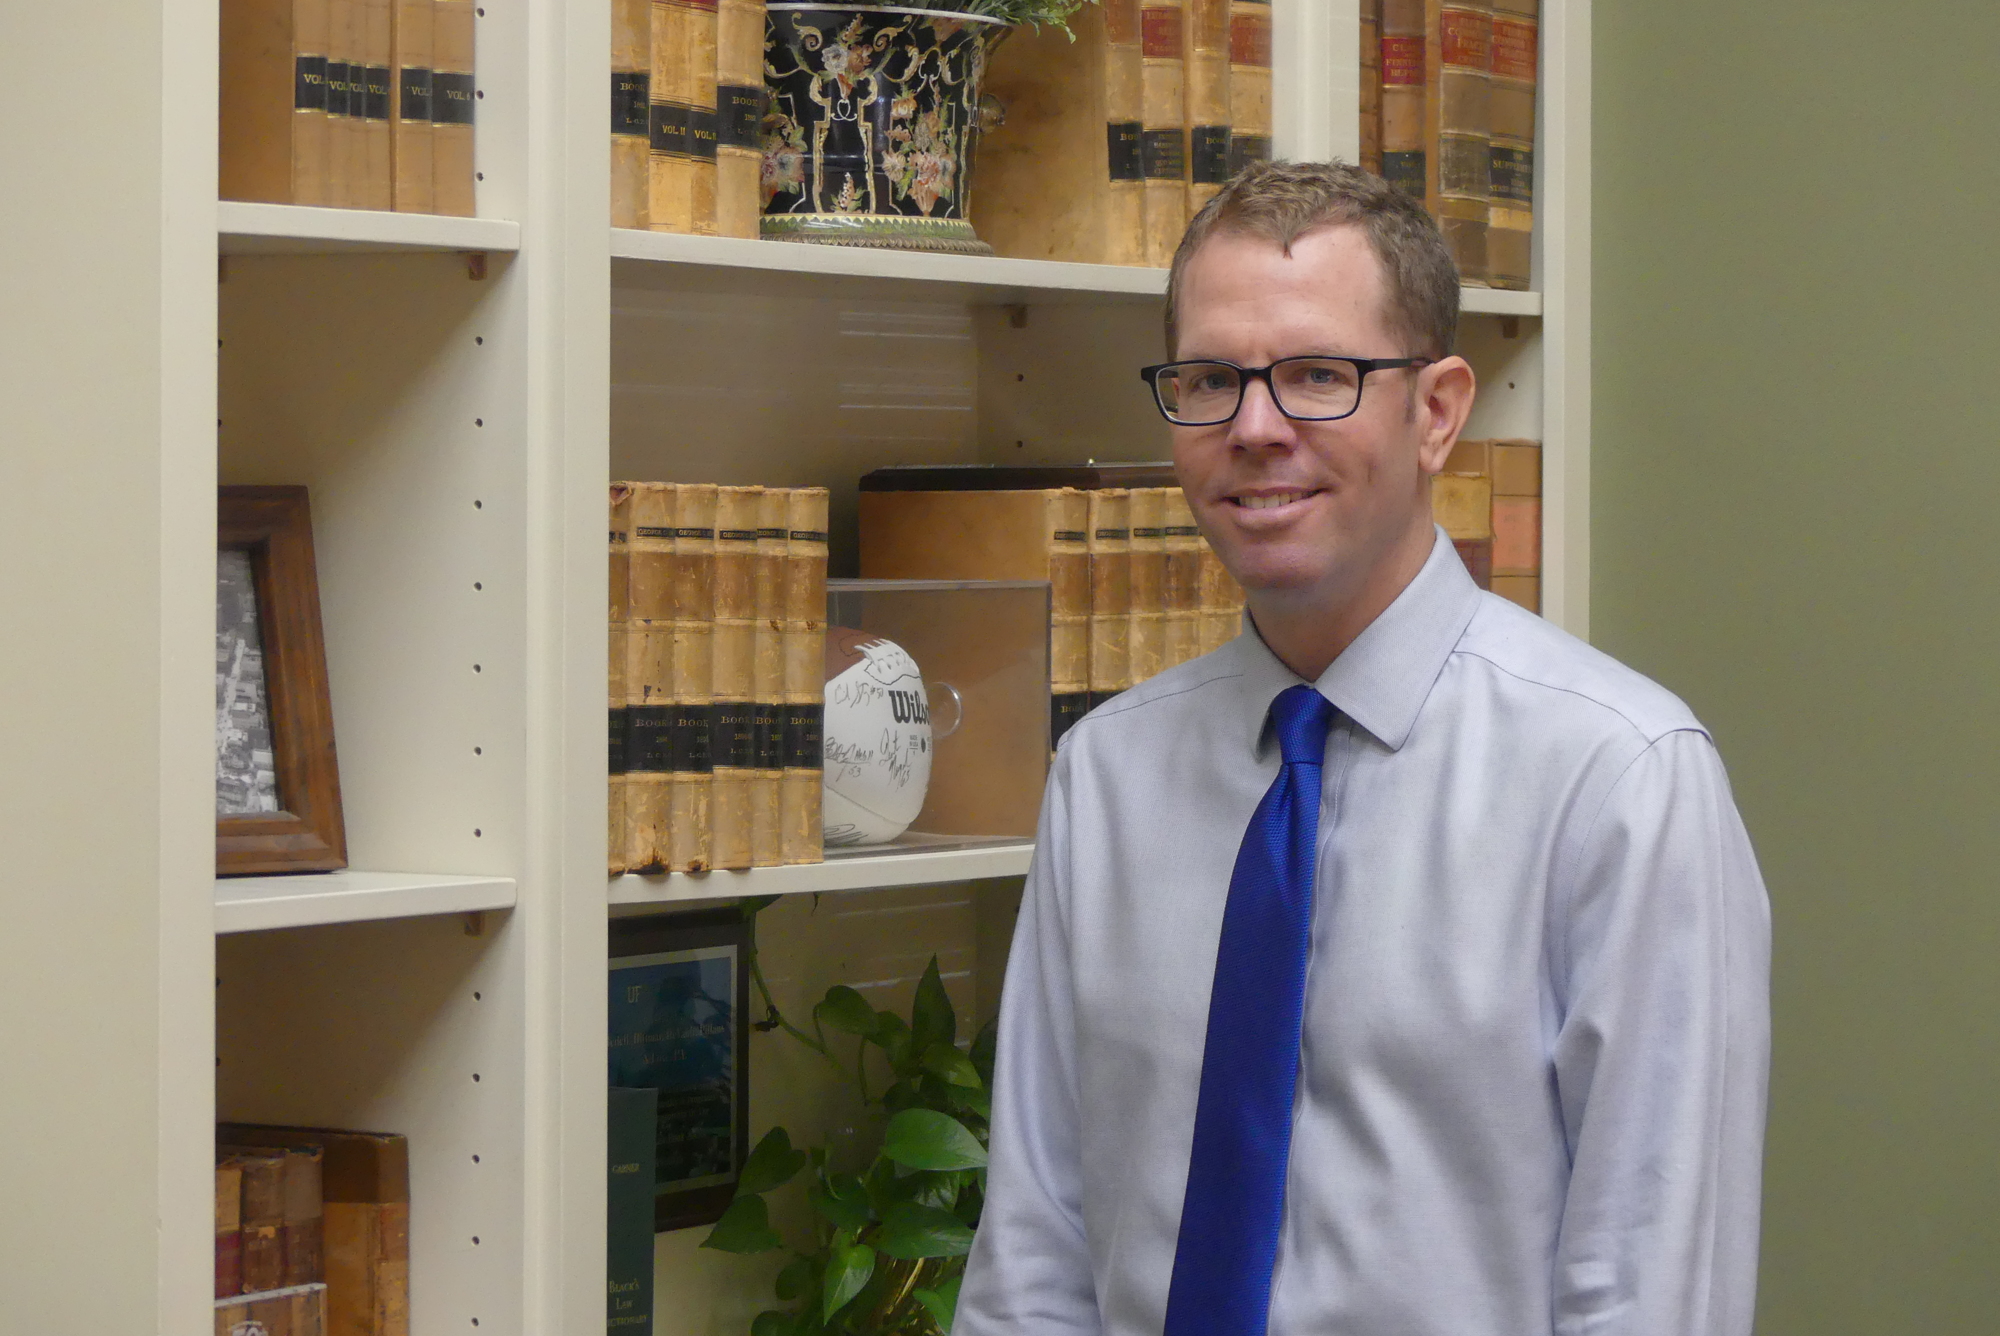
left=860, top=464, right=1242, bottom=742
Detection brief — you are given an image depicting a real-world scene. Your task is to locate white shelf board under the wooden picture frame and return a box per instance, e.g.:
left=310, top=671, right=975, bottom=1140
left=216, top=872, right=518, bottom=934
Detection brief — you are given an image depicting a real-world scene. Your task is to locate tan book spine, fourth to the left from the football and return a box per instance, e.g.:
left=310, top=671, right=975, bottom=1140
left=668, top=482, right=716, bottom=872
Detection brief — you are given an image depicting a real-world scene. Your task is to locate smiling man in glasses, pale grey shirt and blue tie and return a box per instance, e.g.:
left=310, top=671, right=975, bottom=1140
left=954, top=164, right=1770, bottom=1336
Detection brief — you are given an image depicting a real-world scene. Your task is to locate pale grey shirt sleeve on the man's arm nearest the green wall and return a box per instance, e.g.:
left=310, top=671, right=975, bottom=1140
left=1552, top=730, right=1770, bottom=1336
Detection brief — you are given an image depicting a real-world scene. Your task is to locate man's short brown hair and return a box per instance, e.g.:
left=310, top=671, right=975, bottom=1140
left=1166, top=162, right=1458, bottom=360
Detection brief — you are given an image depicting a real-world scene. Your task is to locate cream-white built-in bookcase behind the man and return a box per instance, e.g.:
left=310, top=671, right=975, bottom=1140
left=0, top=0, right=1590, bottom=1336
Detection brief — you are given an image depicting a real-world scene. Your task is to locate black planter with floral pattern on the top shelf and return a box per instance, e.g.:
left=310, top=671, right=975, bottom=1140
left=762, top=2, right=1008, bottom=256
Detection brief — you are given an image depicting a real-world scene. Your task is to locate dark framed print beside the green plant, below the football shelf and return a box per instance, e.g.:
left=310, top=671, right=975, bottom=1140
left=608, top=908, right=750, bottom=1230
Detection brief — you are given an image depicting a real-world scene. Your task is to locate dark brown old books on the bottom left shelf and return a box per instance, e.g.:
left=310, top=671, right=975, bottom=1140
left=216, top=1124, right=410, bottom=1336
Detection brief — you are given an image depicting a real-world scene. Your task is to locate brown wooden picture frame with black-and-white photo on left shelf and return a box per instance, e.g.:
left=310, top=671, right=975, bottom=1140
left=216, top=486, right=348, bottom=876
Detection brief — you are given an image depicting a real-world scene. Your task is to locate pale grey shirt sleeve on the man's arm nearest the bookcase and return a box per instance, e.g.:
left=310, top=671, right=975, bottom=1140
left=952, top=758, right=1102, bottom=1336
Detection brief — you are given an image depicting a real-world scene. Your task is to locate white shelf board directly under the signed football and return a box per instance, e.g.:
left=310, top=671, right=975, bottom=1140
left=610, top=840, right=1034, bottom=906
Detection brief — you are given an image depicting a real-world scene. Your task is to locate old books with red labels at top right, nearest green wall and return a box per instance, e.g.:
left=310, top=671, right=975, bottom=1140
left=1360, top=0, right=1540, bottom=290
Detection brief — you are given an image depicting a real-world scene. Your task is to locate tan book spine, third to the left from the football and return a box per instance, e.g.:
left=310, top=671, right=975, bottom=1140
left=708, top=488, right=762, bottom=868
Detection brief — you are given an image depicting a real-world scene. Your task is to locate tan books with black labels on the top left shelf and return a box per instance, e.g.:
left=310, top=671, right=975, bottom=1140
left=220, top=0, right=478, bottom=216
